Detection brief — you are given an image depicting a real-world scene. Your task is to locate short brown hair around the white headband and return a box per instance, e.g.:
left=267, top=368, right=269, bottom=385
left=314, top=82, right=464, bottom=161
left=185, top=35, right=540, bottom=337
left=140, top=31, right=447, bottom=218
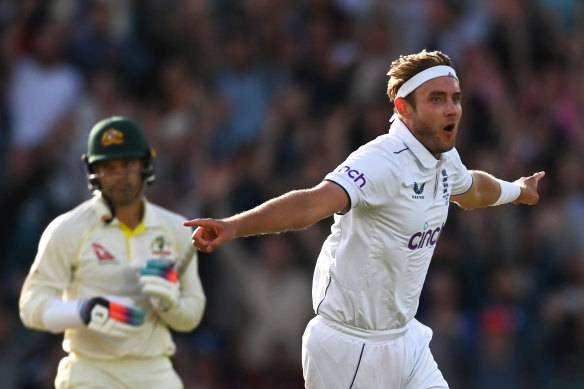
left=387, top=49, right=453, bottom=106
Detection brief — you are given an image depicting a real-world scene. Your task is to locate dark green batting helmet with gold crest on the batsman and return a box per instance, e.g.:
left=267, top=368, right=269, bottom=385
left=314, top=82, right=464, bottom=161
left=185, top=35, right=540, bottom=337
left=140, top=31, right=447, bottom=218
left=82, top=116, right=156, bottom=190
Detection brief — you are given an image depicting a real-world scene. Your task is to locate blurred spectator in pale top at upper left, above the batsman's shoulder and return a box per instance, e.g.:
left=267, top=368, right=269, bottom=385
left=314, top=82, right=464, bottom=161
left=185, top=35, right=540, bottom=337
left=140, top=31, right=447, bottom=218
left=7, top=21, right=83, bottom=180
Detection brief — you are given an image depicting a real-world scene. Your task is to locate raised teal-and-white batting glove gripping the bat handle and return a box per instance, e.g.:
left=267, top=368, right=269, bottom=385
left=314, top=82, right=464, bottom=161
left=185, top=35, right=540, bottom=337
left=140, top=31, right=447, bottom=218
left=140, top=259, right=180, bottom=312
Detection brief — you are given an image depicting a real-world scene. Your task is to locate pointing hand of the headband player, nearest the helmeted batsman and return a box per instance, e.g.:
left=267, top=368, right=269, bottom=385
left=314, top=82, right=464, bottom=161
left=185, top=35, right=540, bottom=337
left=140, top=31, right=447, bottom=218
left=183, top=219, right=235, bottom=253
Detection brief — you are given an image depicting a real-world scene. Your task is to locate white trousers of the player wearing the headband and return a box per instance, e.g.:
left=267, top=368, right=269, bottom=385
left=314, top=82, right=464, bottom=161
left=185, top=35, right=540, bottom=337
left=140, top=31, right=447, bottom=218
left=302, top=316, right=448, bottom=389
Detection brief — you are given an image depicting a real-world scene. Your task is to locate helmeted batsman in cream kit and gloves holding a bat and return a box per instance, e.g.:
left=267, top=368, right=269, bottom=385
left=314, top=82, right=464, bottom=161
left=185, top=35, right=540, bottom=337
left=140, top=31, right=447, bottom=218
left=19, top=117, right=206, bottom=389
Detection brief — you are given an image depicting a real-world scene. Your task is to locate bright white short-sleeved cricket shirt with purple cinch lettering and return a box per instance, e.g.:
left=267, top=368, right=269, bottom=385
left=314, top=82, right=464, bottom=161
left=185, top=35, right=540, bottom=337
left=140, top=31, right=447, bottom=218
left=312, top=119, right=472, bottom=330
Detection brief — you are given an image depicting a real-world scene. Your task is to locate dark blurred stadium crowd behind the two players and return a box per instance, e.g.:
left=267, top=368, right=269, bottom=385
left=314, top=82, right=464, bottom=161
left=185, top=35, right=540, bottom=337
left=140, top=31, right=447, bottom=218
left=0, top=0, right=584, bottom=389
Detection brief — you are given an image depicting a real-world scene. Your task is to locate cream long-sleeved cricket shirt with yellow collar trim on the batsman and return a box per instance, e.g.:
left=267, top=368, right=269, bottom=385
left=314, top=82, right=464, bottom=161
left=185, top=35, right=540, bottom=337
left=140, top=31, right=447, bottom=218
left=20, top=195, right=205, bottom=360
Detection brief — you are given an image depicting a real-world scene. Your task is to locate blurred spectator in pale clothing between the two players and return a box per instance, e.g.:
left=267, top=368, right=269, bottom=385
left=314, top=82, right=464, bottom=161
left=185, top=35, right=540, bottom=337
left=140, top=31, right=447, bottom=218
left=216, top=235, right=313, bottom=378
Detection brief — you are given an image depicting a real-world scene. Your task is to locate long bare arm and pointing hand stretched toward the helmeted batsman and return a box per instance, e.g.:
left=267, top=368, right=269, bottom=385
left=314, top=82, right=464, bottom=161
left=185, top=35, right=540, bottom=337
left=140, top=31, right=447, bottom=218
left=183, top=181, right=350, bottom=253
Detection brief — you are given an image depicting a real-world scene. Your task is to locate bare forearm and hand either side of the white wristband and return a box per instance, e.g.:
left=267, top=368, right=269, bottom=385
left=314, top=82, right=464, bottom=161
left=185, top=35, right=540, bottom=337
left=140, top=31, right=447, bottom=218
left=451, top=170, right=545, bottom=209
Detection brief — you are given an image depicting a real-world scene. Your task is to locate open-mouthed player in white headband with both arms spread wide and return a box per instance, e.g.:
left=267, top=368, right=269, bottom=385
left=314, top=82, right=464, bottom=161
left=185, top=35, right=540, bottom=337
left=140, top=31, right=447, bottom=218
left=184, top=50, right=544, bottom=389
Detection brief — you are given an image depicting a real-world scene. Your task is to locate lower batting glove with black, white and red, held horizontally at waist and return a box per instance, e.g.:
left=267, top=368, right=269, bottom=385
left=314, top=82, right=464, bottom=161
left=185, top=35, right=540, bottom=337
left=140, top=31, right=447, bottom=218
left=79, top=297, right=146, bottom=338
